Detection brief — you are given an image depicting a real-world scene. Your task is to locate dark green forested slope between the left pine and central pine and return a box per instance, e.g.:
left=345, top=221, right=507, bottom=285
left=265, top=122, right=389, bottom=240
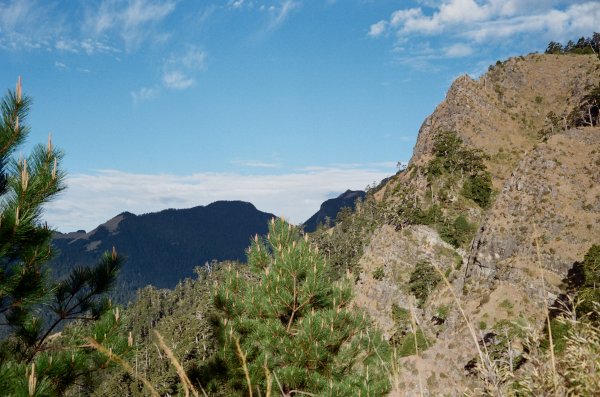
left=95, top=263, right=226, bottom=397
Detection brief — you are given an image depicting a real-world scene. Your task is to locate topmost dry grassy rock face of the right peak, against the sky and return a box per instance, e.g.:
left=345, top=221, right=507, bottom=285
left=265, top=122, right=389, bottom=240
left=410, top=54, right=600, bottom=189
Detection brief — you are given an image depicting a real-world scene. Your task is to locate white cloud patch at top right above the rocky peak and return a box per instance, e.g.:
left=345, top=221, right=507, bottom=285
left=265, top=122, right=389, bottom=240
left=369, top=0, right=600, bottom=67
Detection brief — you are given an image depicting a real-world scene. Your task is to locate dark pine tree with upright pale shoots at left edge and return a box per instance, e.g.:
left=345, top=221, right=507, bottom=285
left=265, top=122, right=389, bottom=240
left=0, top=78, right=127, bottom=396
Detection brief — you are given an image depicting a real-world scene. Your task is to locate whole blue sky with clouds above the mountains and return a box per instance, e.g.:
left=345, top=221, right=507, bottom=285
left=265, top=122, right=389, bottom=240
left=0, top=0, right=600, bottom=231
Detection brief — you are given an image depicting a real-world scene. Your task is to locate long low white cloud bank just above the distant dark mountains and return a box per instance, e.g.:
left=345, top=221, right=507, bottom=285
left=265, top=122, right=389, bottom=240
left=45, top=163, right=396, bottom=232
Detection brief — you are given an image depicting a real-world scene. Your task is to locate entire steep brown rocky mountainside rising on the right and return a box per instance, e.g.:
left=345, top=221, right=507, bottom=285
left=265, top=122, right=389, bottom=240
left=356, top=54, right=600, bottom=396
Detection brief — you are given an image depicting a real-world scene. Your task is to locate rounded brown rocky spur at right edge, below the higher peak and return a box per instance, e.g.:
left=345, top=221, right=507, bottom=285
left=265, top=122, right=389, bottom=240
left=468, top=128, right=600, bottom=287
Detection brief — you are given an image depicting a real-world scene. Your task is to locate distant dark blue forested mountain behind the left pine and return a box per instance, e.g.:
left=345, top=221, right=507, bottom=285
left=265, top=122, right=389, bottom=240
left=50, top=201, right=274, bottom=301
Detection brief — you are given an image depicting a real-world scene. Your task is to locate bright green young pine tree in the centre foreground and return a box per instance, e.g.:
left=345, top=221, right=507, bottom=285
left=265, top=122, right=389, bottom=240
left=214, top=219, right=389, bottom=396
